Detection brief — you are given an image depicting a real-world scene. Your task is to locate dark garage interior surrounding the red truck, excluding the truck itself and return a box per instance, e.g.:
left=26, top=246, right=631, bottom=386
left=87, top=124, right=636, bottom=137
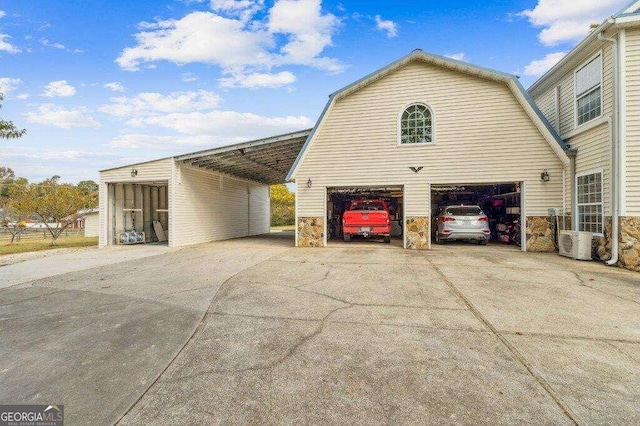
left=327, top=186, right=404, bottom=248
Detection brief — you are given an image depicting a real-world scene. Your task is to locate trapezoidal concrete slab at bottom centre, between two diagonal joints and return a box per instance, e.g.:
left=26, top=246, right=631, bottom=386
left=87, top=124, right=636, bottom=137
left=122, top=317, right=569, bottom=424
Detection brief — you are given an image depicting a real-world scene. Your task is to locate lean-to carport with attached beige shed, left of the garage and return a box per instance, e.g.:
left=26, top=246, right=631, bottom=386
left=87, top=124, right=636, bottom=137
left=99, top=130, right=310, bottom=247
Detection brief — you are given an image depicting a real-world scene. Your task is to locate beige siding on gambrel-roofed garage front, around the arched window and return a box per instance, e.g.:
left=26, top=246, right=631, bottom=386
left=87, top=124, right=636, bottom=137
left=295, top=62, right=563, bottom=217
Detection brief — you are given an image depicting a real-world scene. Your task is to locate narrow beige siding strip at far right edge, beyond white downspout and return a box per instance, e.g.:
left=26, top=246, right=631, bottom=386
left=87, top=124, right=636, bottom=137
left=625, top=30, right=640, bottom=216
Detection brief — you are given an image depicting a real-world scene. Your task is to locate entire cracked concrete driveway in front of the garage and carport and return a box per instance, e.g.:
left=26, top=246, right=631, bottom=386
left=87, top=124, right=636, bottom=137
left=0, top=239, right=640, bottom=424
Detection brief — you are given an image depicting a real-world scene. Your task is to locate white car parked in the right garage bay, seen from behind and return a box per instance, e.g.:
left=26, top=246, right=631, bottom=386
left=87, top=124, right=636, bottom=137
left=435, top=205, right=491, bottom=245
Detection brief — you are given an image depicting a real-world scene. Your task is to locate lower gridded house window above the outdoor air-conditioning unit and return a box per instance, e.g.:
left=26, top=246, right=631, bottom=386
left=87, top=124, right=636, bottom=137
left=576, top=172, right=603, bottom=234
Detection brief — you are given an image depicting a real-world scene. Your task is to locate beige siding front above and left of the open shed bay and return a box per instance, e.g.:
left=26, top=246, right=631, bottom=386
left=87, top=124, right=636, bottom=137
left=98, top=158, right=173, bottom=247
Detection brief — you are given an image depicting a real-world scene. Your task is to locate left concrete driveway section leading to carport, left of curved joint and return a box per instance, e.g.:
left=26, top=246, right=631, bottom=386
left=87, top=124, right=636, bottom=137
left=0, top=238, right=288, bottom=424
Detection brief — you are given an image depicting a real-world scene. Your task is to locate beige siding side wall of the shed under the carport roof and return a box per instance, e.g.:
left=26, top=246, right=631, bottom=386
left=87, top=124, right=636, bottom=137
left=171, top=165, right=270, bottom=246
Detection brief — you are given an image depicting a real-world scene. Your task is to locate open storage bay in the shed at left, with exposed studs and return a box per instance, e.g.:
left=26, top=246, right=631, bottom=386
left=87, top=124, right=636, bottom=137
left=108, top=182, right=169, bottom=245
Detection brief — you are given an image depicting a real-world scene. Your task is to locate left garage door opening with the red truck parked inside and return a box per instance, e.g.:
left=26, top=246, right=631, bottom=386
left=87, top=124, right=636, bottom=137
left=327, top=186, right=404, bottom=248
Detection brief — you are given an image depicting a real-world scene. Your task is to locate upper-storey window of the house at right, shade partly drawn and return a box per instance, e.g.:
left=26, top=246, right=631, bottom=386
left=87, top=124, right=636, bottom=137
left=575, top=55, right=602, bottom=126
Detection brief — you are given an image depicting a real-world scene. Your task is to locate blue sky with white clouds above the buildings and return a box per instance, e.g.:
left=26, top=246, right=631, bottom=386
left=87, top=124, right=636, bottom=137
left=0, top=0, right=627, bottom=182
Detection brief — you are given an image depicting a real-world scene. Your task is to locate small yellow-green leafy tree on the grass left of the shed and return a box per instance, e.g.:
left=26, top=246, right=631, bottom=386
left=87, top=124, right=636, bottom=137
left=19, top=176, right=98, bottom=245
